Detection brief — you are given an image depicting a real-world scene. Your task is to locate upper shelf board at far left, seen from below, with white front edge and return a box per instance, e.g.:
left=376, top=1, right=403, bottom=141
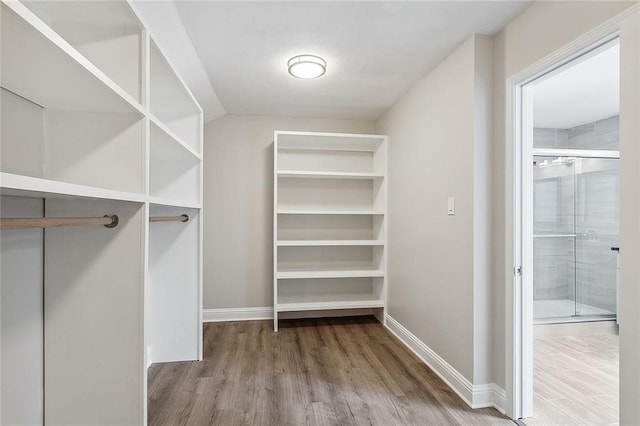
left=1, top=2, right=144, bottom=116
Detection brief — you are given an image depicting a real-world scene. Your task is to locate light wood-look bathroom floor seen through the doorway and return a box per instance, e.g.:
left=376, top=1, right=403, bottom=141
left=525, top=328, right=619, bottom=426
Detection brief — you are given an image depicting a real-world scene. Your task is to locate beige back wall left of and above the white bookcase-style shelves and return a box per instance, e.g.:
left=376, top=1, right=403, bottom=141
left=204, top=115, right=374, bottom=309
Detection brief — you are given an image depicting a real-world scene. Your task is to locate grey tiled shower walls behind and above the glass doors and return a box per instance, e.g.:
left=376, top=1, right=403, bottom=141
left=534, top=116, right=619, bottom=315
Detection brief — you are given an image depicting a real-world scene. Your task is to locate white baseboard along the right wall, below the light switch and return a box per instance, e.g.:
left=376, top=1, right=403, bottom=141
left=385, top=314, right=506, bottom=413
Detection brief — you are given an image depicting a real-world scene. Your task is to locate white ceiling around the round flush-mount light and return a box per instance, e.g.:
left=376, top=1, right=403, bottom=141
left=176, top=0, right=531, bottom=119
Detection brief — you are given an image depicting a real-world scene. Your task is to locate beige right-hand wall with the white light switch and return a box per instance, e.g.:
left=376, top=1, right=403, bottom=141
left=377, top=36, right=492, bottom=384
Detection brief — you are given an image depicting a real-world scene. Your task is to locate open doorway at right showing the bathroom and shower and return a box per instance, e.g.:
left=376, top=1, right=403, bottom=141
left=521, top=38, right=620, bottom=424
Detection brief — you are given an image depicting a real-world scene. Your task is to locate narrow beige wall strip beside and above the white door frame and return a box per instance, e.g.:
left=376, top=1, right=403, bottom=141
left=492, top=1, right=635, bottom=389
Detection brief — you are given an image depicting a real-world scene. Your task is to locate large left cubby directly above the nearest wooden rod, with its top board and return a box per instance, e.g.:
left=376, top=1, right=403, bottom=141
left=0, top=2, right=145, bottom=194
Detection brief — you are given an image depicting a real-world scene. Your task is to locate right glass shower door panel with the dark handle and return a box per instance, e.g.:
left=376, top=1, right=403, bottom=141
left=575, top=158, right=620, bottom=317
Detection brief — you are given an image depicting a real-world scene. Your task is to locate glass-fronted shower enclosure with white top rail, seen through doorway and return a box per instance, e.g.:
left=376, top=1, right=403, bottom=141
left=533, top=149, right=620, bottom=323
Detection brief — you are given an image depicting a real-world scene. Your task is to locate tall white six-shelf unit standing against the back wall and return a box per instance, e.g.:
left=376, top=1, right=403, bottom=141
left=273, top=131, right=387, bottom=331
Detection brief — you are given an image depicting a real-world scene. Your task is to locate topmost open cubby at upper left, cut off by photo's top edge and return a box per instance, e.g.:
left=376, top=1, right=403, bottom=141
left=23, top=0, right=143, bottom=103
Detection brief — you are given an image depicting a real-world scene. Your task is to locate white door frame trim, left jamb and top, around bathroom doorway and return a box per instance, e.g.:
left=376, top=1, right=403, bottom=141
left=504, top=7, right=638, bottom=419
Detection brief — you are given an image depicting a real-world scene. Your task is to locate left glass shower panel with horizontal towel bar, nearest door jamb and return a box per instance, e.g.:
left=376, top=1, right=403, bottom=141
left=533, top=156, right=577, bottom=322
